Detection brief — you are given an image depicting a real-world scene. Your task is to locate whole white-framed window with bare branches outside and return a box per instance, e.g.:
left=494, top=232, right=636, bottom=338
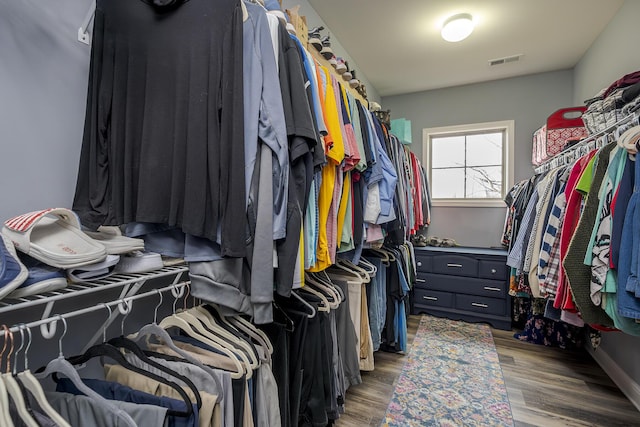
left=423, top=120, right=514, bottom=207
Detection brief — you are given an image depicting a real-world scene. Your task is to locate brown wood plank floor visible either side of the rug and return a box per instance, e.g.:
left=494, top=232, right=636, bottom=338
left=336, top=316, right=640, bottom=427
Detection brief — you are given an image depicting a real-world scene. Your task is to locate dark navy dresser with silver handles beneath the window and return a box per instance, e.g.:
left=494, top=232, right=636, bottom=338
left=411, top=246, right=511, bottom=330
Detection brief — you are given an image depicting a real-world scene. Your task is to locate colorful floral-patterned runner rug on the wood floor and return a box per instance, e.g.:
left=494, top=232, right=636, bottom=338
left=382, top=316, right=513, bottom=427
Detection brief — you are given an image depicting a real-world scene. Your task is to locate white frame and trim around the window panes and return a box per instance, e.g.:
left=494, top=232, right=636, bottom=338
left=422, top=120, right=515, bottom=208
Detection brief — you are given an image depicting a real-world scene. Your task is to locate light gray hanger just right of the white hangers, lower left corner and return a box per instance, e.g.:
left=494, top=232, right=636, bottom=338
left=35, top=315, right=137, bottom=427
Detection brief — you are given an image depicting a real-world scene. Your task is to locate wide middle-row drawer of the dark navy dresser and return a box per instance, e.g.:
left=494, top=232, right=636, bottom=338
left=416, top=273, right=508, bottom=298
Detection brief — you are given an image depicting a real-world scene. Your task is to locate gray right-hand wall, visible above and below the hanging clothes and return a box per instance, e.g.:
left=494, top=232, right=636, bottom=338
left=573, top=0, right=640, bottom=398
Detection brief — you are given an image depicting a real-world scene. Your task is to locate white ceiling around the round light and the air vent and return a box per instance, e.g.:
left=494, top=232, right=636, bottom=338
left=308, top=0, right=624, bottom=96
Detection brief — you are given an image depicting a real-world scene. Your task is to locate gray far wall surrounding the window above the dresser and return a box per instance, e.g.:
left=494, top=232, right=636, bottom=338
left=382, top=71, right=573, bottom=246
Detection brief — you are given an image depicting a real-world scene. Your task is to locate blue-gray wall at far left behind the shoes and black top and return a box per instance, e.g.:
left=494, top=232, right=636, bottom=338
left=0, top=0, right=90, bottom=221
